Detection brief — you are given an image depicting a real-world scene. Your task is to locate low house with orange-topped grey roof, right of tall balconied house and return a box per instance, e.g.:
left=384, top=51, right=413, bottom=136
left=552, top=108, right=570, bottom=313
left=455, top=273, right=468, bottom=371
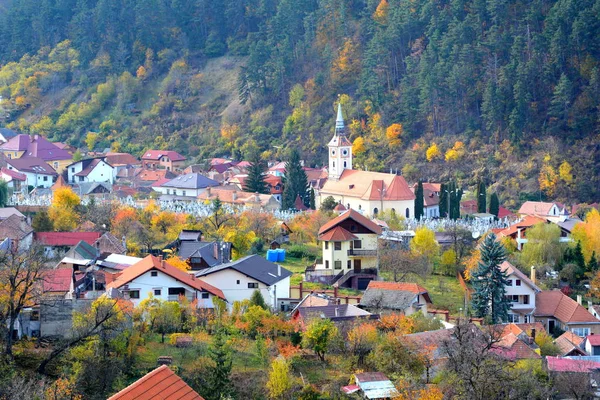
left=359, top=281, right=431, bottom=316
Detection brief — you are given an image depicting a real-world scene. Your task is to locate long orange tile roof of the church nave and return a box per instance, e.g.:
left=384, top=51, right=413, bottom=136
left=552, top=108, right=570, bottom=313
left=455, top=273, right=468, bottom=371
left=321, top=169, right=415, bottom=201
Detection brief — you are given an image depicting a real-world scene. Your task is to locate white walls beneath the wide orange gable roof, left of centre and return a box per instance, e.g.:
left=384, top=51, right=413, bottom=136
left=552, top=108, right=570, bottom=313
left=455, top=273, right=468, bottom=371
left=110, top=270, right=214, bottom=308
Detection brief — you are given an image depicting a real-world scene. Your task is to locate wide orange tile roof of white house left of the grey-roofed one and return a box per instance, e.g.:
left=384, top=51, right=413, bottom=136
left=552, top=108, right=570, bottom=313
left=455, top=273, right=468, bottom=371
left=106, top=256, right=225, bottom=300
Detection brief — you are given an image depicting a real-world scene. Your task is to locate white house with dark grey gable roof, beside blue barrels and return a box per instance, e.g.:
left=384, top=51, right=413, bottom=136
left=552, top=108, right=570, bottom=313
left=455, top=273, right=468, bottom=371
left=196, top=255, right=292, bottom=310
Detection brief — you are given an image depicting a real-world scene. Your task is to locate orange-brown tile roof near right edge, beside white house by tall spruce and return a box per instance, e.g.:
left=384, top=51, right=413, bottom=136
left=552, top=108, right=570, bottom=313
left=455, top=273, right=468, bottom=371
left=534, top=290, right=600, bottom=325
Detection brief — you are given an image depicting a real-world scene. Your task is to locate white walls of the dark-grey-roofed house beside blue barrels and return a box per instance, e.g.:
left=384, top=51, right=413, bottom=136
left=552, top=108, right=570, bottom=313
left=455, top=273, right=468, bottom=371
left=201, top=269, right=290, bottom=307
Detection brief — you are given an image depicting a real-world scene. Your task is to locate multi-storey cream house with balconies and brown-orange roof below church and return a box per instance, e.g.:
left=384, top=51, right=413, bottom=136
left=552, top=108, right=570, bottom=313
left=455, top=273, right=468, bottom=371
left=314, top=209, right=382, bottom=290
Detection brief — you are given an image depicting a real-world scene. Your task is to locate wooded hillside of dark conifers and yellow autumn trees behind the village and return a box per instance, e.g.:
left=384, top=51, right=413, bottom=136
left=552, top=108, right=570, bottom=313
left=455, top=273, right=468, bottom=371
left=0, top=0, right=600, bottom=207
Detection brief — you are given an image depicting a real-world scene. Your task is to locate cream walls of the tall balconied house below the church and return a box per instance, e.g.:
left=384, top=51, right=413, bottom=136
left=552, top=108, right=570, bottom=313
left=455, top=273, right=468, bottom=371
left=316, top=233, right=378, bottom=274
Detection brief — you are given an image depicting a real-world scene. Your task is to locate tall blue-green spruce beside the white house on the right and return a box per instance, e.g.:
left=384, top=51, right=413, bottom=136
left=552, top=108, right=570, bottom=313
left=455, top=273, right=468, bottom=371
left=471, top=233, right=511, bottom=324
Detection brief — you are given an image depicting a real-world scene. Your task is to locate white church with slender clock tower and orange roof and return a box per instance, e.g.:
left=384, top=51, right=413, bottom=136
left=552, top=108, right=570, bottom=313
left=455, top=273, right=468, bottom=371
left=317, top=104, right=415, bottom=218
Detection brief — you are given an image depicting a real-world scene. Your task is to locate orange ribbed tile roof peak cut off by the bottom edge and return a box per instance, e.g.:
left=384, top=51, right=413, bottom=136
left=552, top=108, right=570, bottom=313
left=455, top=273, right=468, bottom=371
left=108, top=365, right=204, bottom=400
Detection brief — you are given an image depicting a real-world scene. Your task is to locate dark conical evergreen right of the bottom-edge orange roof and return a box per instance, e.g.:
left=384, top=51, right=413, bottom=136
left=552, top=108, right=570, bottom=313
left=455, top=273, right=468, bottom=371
left=204, top=329, right=234, bottom=400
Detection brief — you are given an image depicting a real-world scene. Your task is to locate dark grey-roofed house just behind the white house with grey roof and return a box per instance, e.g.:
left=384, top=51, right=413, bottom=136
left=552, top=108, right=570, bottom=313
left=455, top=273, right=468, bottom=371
left=179, top=240, right=231, bottom=271
